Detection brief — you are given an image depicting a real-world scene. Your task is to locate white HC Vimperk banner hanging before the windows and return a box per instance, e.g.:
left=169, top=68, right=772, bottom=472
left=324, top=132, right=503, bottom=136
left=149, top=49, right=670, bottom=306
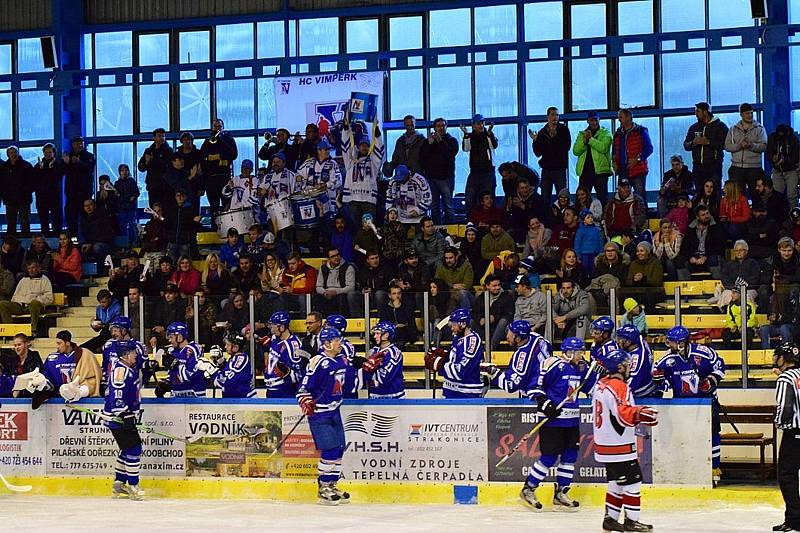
left=275, top=72, right=384, bottom=136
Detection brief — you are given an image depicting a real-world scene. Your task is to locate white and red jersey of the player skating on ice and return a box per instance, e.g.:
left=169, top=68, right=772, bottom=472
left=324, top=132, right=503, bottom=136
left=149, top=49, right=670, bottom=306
left=592, top=377, right=640, bottom=463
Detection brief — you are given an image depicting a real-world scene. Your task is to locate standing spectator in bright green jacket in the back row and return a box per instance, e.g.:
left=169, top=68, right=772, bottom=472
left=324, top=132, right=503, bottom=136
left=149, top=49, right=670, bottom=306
left=572, top=111, right=613, bottom=205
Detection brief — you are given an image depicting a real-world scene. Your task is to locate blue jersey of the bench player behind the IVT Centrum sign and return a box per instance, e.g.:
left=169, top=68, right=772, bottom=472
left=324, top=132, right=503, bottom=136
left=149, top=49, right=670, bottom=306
left=439, top=331, right=483, bottom=398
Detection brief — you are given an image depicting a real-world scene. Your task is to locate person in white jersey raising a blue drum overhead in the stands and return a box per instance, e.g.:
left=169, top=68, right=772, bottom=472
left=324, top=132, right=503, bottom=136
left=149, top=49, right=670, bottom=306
left=342, top=110, right=384, bottom=223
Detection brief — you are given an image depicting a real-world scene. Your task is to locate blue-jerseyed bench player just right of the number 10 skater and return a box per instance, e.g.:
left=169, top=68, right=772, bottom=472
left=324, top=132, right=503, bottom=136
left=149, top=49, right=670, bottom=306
left=155, top=322, right=208, bottom=398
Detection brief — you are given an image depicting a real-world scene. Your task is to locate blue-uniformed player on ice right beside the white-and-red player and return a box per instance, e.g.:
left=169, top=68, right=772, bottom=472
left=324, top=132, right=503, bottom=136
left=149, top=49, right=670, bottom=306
left=520, top=337, right=597, bottom=511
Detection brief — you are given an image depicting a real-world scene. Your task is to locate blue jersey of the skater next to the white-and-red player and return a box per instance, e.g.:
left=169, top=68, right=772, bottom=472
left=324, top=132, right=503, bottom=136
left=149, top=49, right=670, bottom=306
left=529, top=357, right=597, bottom=427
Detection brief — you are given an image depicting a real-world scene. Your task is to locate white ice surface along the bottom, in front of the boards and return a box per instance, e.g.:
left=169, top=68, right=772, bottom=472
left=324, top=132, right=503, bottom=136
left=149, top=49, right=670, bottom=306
left=0, top=494, right=783, bottom=533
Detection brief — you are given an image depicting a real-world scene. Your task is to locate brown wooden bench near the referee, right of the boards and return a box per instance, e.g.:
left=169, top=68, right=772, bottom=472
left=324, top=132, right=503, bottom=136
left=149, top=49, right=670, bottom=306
left=720, top=405, right=778, bottom=482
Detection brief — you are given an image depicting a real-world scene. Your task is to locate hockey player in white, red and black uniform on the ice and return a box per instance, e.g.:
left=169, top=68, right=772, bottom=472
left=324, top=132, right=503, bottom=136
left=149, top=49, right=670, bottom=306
left=592, top=350, right=658, bottom=532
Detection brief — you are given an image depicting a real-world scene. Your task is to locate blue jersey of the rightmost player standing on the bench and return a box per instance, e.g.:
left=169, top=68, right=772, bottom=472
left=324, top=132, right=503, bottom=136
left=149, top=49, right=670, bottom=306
left=653, top=343, right=725, bottom=398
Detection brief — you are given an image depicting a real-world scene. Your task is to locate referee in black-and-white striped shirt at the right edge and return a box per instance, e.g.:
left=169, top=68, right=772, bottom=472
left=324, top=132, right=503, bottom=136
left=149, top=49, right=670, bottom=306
left=772, top=342, right=800, bottom=531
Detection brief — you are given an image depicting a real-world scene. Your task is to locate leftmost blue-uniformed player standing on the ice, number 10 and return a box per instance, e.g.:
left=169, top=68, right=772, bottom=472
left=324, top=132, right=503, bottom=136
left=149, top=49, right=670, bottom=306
left=103, top=341, right=144, bottom=500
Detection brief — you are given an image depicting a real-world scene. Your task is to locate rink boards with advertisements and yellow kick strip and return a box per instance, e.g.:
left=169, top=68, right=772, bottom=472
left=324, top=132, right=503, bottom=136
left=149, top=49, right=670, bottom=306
left=0, top=399, right=756, bottom=503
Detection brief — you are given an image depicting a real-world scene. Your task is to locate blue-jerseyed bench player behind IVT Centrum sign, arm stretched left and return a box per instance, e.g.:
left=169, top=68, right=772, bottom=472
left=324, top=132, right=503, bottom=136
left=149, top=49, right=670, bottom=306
left=425, top=309, right=483, bottom=398
